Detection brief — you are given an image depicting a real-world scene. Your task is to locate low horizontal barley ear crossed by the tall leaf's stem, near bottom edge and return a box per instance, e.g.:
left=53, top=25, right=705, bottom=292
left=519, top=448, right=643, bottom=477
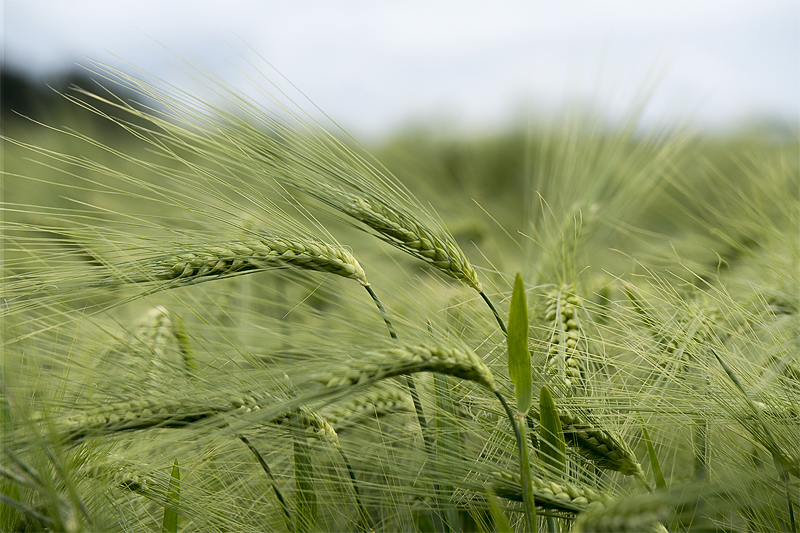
left=491, top=472, right=611, bottom=513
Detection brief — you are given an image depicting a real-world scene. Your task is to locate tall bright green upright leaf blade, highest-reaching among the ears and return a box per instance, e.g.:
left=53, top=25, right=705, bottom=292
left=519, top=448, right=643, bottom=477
left=507, top=273, right=533, bottom=414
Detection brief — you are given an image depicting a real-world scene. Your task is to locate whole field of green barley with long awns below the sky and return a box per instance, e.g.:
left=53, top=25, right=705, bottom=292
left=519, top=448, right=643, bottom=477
left=0, top=56, right=800, bottom=533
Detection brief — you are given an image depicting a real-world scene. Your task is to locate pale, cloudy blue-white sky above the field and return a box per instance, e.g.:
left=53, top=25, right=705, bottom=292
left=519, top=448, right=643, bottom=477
left=2, top=0, right=800, bottom=136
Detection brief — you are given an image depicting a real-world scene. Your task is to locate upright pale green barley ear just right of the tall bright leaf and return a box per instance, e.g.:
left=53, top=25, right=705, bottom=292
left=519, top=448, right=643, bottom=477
left=544, top=285, right=586, bottom=388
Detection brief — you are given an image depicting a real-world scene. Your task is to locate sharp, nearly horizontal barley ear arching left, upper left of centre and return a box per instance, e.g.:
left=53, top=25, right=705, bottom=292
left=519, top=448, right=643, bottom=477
left=124, top=235, right=369, bottom=286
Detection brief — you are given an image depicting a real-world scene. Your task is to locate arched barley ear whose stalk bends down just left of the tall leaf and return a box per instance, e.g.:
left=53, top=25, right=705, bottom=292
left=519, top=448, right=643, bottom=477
left=320, top=346, right=498, bottom=392
